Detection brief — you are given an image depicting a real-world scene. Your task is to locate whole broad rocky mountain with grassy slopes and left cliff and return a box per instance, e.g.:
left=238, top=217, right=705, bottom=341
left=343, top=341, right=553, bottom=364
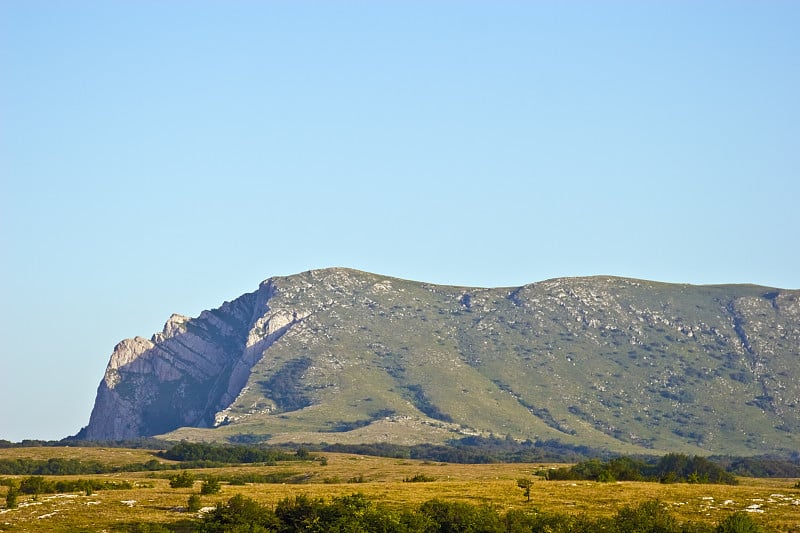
left=79, top=268, right=800, bottom=455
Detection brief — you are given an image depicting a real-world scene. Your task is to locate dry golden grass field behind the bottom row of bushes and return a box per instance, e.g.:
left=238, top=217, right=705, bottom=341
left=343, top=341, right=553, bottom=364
left=0, top=448, right=800, bottom=532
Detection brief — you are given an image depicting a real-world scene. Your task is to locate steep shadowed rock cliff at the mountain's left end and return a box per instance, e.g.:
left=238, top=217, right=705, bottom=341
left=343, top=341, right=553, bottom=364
left=80, top=289, right=267, bottom=440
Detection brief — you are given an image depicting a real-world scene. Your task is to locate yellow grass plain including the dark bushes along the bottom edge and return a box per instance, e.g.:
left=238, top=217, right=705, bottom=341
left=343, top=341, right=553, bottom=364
left=0, top=448, right=800, bottom=533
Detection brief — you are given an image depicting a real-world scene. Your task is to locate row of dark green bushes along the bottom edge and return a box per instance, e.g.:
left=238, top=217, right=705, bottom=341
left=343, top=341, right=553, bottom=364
left=198, top=494, right=761, bottom=533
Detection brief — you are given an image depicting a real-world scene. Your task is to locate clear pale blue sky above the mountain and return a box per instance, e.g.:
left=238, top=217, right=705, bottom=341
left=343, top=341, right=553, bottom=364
left=0, top=0, right=800, bottom=441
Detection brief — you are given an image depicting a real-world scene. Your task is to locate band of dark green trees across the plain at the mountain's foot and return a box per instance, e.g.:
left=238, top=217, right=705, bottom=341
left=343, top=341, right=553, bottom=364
left=0, top=437, right=800, bottom=483
